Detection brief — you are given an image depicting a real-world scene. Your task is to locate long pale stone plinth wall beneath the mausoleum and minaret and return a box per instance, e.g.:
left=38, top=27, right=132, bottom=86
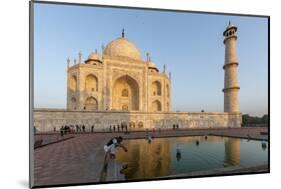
left=33, top=109, right=242, bottom=132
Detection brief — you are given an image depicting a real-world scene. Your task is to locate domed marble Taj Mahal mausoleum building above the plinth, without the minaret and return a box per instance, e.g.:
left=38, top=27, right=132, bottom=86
left=67, top=31, right=171, bottom=112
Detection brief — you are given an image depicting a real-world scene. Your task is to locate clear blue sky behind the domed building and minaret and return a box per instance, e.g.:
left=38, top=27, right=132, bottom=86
left=34, top=3, right=268, bottom=116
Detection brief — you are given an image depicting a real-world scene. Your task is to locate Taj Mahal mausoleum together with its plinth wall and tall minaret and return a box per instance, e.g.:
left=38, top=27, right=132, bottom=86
left=33, top=22, right=242, bottom=132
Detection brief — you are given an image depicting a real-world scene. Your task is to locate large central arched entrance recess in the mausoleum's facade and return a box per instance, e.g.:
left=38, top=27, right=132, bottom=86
left=112, top=75, right=139, bottom=111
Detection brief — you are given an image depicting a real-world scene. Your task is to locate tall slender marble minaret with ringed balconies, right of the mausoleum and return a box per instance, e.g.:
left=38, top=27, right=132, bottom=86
left=223, top=21, right=240, bottom=112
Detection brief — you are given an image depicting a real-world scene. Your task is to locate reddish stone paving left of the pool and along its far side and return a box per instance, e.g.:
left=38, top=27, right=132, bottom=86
left=34, top=128, right=267, bottom=186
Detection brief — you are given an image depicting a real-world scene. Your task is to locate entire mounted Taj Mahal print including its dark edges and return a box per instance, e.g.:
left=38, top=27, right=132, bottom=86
left=29, top=1, right=270, bottom=188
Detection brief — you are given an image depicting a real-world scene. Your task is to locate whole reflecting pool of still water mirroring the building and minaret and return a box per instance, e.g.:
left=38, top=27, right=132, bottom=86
left=117, top=136, right=268, bottom=180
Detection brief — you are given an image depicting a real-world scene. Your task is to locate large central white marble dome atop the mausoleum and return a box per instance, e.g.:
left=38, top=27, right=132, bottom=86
left=104, top=37, right=141, bottom=60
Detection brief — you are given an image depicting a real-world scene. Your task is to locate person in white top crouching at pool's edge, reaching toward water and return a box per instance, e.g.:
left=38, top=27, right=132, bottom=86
left=103, top=136, right=128, bottom=168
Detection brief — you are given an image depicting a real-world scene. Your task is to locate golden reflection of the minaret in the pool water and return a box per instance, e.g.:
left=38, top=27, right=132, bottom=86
left=224, top=138, right=240, bottom=166
